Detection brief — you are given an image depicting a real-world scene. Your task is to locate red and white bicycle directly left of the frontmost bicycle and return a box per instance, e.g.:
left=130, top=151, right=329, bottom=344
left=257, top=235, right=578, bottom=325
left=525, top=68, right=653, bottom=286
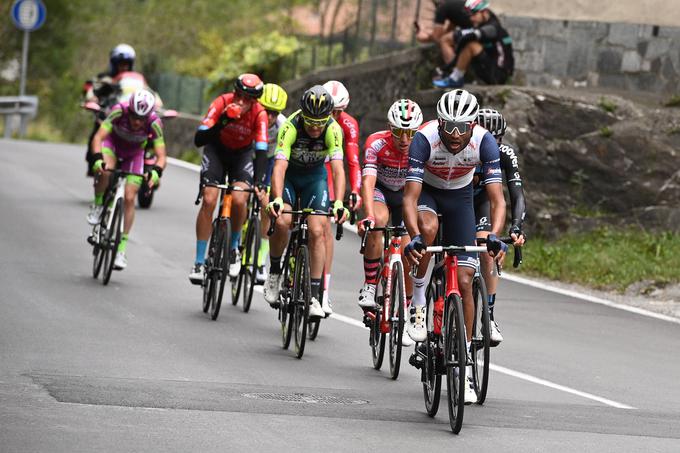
left=361, top=225, right=408, bottom=379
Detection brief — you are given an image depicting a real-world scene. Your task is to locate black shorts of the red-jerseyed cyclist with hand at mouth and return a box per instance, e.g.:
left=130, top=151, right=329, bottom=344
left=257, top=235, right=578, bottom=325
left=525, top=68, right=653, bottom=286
left=201, top=143, right=253, bottom=186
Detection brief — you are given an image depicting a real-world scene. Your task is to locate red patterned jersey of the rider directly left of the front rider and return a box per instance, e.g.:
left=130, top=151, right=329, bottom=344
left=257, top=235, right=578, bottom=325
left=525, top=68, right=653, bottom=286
left=363, top=131, right=408, bottom=191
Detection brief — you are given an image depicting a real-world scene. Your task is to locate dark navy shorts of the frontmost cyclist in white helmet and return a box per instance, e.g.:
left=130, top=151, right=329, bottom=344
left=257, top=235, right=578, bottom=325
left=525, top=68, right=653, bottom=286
left=418, top=183, right=477, bottom=268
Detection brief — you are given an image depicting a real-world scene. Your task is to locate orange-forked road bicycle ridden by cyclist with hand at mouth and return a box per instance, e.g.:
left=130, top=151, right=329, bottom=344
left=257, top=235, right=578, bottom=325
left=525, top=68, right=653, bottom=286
left=195, top=183, right=252, bottom=321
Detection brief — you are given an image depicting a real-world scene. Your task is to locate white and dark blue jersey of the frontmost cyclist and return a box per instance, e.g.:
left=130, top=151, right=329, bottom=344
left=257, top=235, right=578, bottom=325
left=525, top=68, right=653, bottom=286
left=406, top=120, right=503, bottom=190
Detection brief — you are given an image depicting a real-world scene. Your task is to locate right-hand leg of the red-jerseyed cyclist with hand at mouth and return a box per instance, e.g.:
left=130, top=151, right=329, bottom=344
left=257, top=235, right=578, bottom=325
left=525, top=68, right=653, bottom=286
left=227, top=149, right=253, bottom=250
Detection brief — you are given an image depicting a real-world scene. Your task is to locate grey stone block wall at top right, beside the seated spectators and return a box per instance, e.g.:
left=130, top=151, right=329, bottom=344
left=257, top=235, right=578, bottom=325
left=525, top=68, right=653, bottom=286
left=501, top=16, right=680, bottom=95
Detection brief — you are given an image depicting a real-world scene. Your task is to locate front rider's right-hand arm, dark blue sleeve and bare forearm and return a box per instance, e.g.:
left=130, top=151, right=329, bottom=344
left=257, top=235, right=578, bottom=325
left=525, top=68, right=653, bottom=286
left=479, top=132, right=505, bottom=236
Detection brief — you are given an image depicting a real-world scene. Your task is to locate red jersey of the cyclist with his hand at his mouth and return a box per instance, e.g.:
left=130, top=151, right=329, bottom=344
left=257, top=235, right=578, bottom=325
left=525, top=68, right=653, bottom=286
left=201, top=93, right=269, bottom=149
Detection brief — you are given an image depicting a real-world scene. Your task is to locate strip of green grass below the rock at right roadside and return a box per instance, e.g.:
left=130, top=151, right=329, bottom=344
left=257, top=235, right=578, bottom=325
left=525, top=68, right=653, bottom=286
left=520, top=228, right=680, bottom=291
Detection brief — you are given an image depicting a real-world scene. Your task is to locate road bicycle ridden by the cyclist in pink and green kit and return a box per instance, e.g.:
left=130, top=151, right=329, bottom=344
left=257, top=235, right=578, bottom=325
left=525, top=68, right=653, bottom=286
left=87, top=169, right=141, bottom=285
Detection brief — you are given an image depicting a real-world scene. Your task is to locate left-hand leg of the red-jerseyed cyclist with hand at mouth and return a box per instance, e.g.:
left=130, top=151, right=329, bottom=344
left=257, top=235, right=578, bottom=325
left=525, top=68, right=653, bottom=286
left=195, top=144, right=225, bottom=264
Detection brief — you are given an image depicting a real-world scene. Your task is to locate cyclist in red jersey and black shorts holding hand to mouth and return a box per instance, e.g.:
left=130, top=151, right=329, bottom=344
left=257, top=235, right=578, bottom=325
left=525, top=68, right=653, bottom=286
left=189, top=74, right=269, bottom=285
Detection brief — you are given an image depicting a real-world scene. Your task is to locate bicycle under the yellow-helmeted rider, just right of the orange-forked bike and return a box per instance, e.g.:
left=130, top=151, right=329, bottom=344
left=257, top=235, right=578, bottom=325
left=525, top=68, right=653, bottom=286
left=231, top=189, right=261, bottom=313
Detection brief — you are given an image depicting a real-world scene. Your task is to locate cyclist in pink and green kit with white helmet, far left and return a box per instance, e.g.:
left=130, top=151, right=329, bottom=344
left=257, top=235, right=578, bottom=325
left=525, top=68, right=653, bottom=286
left=87, top=90, right=166, bottom=270
